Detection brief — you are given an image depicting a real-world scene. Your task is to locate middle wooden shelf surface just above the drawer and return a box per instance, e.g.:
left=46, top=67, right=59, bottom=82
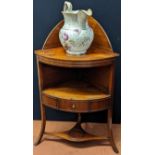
left=42, top=81, right=110, bottom=101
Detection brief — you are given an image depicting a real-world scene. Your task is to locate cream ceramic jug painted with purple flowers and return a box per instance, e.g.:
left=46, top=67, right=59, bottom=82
left=59, top=1, right=94, bottom=55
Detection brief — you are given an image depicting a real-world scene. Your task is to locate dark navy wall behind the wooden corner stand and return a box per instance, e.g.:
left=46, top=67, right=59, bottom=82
left=33, top=0, right=121, bottom=123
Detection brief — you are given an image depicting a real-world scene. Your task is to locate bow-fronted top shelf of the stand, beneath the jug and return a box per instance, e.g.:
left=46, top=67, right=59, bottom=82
left=35, top=47, right=118, bottom=67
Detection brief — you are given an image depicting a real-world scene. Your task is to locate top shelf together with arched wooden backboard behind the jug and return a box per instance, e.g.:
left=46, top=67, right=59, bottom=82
left=35, top=17, right=118, bottom=68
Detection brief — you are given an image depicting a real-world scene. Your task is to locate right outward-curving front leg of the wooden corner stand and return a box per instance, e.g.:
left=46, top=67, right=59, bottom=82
left=108, top=109, right=118, bottom=153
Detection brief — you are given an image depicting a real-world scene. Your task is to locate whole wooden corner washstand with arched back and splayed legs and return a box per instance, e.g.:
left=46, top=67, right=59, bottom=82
left=35, top=17, right=118, bottom=153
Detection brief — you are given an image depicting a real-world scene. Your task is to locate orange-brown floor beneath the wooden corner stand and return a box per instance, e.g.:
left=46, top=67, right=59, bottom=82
left=33, top=121, right=121, bottom=155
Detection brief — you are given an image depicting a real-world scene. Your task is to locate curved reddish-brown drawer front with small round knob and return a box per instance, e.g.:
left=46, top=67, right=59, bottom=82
left=42, top=95, right=111, bottom=113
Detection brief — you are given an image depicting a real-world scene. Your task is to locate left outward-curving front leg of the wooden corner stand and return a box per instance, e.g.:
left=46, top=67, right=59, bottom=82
left=34, top=105, right=46, bottom=146
